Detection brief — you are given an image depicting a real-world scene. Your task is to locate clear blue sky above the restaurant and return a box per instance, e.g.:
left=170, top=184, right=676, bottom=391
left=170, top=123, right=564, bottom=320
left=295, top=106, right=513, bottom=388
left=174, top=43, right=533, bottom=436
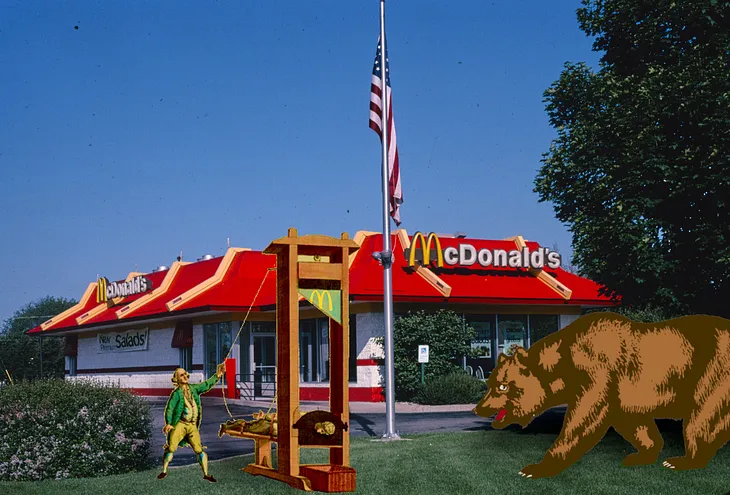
left=0, top=0, right=599, bottom=320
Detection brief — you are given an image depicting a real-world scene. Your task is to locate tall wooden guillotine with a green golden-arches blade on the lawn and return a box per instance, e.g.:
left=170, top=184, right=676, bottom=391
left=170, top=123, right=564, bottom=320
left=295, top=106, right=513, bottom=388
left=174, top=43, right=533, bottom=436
left=244, top=228, right=359, bottom=492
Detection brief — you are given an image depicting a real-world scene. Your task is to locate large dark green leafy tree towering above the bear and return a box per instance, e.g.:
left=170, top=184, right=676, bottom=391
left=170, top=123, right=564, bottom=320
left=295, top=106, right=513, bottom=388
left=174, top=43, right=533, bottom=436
left=535, top=0, right=730, bottom=317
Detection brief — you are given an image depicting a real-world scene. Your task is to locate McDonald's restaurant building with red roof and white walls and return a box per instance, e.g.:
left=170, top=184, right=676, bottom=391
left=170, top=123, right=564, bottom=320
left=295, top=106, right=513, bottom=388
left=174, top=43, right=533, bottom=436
left=29, top=229, right=613, bottom=401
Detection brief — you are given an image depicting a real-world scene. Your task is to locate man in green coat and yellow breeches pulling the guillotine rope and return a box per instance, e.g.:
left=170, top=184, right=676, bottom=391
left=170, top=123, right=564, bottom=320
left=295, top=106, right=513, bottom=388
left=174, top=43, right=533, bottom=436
left=157, top=364, right=225, bottom=483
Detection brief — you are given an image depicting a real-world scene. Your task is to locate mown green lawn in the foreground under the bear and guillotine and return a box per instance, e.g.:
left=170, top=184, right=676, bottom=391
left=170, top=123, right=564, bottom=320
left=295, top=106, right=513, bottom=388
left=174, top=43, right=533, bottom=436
left=5, top=431, right=730, bottom=495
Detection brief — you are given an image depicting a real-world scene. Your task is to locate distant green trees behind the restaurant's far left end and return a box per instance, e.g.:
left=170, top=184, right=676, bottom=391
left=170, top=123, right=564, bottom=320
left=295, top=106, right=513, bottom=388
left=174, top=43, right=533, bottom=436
left=0, top=296, right=76, bottom=380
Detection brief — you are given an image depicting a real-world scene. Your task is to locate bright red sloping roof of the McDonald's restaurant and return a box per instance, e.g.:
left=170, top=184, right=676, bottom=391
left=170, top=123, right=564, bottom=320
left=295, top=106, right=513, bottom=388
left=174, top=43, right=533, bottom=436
left=28, top=229, right=614, bottom=333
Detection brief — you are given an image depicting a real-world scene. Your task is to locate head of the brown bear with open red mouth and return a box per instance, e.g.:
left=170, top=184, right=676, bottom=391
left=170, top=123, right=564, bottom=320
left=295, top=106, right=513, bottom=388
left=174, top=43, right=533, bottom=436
left=473, top=347, right=548, bottom=430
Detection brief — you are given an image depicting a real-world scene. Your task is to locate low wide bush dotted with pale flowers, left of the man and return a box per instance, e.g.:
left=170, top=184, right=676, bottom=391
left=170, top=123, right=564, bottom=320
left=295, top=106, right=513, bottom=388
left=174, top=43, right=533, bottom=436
left=0, top=380, right=152, bottom=481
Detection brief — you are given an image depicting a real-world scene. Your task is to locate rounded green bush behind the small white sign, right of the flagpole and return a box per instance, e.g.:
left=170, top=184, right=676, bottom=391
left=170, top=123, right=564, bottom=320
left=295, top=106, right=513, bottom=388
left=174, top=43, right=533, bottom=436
left=379, top=310, right=476, bottom=401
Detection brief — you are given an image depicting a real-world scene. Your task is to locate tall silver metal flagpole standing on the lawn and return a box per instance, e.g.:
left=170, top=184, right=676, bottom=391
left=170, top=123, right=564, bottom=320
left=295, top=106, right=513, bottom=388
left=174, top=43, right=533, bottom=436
left=380, top=0, right=399, bottom=439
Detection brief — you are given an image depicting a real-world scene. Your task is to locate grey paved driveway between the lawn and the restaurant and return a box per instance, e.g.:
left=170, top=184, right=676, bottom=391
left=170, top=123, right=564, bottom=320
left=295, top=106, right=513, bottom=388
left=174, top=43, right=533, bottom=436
left=145, top=397, right=564, bottom=467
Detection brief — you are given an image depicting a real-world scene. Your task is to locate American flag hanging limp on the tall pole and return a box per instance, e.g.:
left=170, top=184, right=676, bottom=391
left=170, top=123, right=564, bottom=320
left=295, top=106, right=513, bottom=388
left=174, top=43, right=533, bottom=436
left=370, top=38, right=403, bottom=225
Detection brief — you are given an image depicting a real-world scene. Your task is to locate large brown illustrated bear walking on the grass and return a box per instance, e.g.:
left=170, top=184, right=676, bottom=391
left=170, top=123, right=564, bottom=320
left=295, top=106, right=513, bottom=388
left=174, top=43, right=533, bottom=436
left=474, top=313, right=730, bottom=478
